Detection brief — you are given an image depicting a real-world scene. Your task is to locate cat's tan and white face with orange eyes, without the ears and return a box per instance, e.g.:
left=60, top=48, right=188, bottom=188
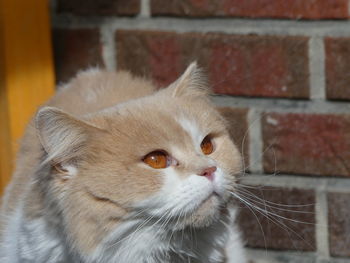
left=84, top=96, right=240, bottom=226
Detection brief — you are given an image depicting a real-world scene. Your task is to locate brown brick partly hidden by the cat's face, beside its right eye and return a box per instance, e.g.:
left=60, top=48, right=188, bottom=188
left=218, top=107, right=249, bottom=167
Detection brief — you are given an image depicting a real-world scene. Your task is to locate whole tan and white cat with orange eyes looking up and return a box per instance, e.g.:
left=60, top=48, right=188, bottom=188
left=0, top=63, right=246, bottom=263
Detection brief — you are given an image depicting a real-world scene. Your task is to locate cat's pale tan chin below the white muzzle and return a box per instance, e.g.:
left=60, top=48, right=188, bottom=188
left=185, top=193, right=222, bottom=228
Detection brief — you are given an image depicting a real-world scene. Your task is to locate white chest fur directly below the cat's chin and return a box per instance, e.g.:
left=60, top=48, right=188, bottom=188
left=87, top=210, right=246, bottom=263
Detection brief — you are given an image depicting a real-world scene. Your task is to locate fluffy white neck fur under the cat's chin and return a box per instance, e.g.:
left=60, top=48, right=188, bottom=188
left=90, top=206, right=234, bottom=263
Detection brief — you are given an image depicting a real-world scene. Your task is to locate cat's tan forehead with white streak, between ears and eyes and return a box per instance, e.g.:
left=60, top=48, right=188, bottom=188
left=94, top=97, right=221, bottom=155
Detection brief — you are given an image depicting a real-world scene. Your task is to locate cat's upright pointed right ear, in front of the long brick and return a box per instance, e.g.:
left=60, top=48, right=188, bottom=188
left=169, top=62, right=209, bottom=97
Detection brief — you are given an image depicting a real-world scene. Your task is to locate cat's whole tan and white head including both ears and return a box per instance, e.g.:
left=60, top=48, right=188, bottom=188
left=36, top=64, right=241, bottom=253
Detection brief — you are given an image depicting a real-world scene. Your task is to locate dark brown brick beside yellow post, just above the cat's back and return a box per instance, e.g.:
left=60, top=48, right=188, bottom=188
left=53, top=29, right=103, bottom=82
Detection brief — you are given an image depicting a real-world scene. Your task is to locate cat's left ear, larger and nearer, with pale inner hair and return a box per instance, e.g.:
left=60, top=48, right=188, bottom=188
left=35, top=107, right=97, bottom=167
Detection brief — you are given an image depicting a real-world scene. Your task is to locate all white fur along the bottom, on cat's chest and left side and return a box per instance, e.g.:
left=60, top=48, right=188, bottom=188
left=0, top=207, right=245, bottom=263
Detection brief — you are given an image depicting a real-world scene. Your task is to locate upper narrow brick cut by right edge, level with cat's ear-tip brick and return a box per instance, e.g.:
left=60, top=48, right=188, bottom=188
left=325, top=37, right=350, bottom=100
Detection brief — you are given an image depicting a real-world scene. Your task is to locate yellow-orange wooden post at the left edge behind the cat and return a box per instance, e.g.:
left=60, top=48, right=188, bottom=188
left=0, top=0, right=54, bottom=194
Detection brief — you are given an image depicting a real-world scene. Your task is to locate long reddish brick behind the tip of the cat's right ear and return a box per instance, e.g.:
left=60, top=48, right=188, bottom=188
left=116, top=30, right=309, bottom=98
